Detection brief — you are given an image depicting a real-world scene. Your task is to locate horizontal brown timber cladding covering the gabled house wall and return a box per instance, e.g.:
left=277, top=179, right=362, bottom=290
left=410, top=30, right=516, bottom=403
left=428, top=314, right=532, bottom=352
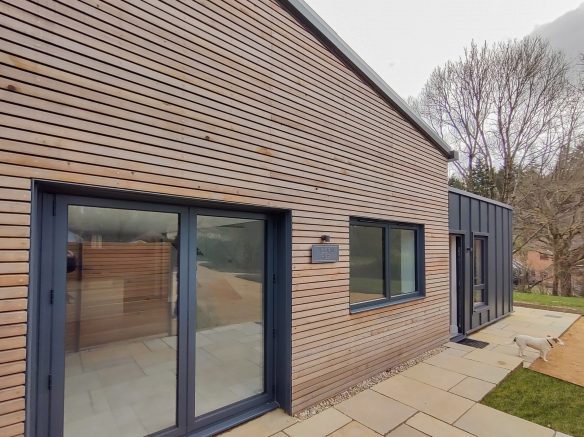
left=0, top=0, right=448, bottom=426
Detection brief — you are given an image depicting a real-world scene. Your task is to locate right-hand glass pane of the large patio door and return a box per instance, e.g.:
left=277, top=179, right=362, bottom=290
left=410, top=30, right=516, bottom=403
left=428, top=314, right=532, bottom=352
left=195, top=216, right=265, bottom=416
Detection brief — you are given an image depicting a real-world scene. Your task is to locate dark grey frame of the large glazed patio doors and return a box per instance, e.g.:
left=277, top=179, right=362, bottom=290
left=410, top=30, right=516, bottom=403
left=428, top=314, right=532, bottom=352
left=26, top=188, right=291, bottom=437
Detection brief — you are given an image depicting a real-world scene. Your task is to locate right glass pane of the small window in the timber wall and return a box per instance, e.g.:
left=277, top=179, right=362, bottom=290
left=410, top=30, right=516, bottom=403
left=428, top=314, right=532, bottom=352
left=389, top=228, right=417, bottom=296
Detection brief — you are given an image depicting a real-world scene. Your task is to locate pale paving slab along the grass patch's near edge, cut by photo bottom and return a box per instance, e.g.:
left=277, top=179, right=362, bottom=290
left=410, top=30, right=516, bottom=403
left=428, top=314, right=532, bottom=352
left=454, top=404, right=555, bottom=437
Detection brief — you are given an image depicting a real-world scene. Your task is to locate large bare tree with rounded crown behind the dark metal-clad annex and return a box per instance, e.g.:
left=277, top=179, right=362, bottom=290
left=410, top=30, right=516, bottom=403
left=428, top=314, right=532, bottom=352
left=411, top=37, right=572, bottom=203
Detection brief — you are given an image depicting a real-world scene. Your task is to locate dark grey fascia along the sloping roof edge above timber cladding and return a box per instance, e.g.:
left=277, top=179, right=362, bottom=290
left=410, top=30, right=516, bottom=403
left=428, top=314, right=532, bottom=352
left=279, top=0, right=458, bottom=161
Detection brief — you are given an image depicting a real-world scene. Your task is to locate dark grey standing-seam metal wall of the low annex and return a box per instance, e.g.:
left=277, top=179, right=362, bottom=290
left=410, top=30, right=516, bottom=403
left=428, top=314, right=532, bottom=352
left=448, top=188, right=513, bottom=332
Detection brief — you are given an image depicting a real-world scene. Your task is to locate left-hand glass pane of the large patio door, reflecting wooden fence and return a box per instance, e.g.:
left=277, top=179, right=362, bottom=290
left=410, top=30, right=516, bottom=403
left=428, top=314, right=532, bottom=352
left=64, top=206, right=179, bottom=437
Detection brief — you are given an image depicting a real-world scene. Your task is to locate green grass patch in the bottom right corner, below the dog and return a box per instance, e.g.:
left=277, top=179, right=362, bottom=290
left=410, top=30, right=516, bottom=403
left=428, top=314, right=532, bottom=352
left=482, top=369, right=584, bottom=437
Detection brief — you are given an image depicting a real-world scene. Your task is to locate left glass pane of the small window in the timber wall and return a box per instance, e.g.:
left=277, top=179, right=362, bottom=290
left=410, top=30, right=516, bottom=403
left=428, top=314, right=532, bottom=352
left=349, top=225, right=384, bottom=303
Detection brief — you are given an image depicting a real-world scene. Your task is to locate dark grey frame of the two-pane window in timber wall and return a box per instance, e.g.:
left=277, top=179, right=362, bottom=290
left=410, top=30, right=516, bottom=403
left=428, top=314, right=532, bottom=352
left=349, top=217, right=426, bottom=313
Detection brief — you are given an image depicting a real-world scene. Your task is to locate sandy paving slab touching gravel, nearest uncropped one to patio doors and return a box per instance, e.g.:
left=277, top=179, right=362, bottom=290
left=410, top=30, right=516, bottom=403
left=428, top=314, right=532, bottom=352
left=335, top=390, right=416, bottom=434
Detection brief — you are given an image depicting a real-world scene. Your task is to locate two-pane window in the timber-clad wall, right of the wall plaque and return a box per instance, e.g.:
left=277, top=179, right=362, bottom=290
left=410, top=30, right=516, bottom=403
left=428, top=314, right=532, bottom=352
left=349, top=220, right=424, bottom=309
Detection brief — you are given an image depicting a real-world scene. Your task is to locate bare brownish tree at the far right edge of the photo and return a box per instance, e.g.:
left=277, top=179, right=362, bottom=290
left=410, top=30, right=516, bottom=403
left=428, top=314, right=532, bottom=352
left=514, top=87, right=584, bottom=296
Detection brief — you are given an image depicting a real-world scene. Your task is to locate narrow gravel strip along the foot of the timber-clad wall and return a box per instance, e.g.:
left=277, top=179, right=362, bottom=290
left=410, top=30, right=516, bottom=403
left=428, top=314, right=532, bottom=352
left=294, top=346, right=448, bottom=420
